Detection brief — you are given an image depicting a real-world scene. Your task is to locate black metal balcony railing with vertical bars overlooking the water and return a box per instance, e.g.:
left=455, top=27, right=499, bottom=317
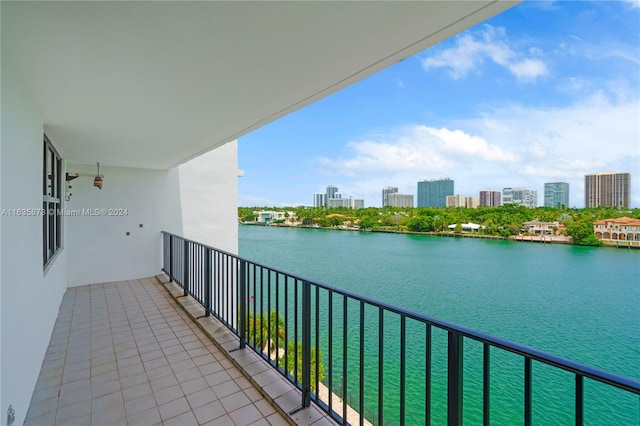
left=163, top=232, right=640, bottom=425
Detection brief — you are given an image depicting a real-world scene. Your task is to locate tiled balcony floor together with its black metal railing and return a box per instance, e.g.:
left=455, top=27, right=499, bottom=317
left=25, top=233, right=640, bottom=425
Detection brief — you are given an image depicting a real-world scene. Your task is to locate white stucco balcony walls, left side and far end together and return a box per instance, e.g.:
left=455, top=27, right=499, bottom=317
left=0, top=50, right=238, bottom=425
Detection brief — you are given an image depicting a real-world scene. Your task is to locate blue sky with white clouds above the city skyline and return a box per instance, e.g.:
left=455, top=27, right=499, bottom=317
left=238, top=0, right=640, bottom=207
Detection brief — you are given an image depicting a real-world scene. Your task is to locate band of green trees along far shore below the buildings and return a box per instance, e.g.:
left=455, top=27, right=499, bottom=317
left=238, top=204, right=640, bottom=245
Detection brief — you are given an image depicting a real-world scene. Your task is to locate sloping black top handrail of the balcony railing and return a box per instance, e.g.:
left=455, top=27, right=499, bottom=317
left=162, top=231, right=640, bottom=395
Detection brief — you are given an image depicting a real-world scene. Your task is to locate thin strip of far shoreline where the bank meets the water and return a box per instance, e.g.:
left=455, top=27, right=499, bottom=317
left=238, top=222, right=640, bottom=249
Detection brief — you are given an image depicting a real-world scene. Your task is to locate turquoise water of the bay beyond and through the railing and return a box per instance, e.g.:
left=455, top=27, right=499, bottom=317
left=239, top=226, right=640, bottom=425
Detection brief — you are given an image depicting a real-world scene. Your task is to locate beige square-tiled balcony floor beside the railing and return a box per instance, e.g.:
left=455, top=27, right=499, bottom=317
left=25, top=278, right=287, bottom=426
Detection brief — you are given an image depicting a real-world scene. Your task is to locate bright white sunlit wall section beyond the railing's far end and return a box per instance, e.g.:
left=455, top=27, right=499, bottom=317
left=178, top=141, right=238, bottom=254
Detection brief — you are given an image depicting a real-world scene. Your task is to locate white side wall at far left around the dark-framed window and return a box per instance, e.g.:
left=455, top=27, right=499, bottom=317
left=0, top=63, right=68, bottom=425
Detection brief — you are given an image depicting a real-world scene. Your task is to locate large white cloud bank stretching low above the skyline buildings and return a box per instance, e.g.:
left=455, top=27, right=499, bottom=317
left=318, top=93, right=640, bottom=206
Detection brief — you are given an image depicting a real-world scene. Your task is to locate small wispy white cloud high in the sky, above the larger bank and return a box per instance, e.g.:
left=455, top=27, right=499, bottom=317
left=422, top=25, right=549, bottom=82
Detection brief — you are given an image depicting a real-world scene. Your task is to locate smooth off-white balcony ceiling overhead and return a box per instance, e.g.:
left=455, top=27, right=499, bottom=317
left=1, top=0, right=517, bottom=169
